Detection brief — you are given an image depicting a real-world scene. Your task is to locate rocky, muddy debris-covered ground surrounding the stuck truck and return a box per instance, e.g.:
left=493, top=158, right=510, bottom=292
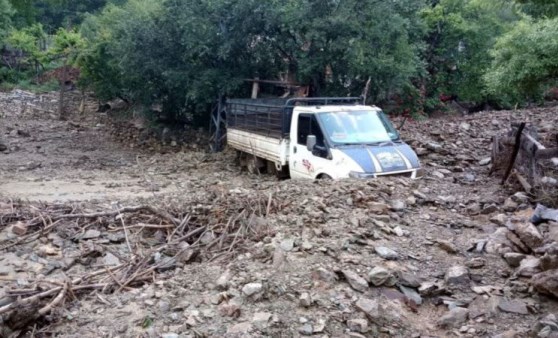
left=0, top=93, right=558, bottom=338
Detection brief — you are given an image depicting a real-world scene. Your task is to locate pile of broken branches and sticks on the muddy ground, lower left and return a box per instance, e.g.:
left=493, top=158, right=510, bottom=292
left=0, top=195, right=276, bottom=337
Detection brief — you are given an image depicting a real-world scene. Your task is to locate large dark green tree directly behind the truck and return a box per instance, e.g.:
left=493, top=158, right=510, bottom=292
left=82, top=0, right=424, bottom=121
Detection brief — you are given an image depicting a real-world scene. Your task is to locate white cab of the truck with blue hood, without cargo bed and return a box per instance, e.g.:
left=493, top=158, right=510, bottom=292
left=289, top=105, right=420, bottom=179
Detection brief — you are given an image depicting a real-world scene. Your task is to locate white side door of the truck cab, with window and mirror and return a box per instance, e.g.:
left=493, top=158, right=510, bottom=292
left=289, top=114, right=331, bottom=179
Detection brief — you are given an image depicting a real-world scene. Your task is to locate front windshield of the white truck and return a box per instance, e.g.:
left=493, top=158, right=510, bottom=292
left=318, top=110, right=399, bottom=144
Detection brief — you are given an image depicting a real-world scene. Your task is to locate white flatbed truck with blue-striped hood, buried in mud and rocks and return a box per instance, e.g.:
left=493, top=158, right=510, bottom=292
left=225, top=97, right=420, bottom=179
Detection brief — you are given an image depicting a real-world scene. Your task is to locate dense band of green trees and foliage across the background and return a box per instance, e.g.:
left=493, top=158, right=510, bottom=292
left=0, top=0, right=558, bottom=118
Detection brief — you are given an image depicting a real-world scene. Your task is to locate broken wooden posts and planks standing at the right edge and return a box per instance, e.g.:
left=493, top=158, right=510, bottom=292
left=491, top=122, right=558, bottom=208
